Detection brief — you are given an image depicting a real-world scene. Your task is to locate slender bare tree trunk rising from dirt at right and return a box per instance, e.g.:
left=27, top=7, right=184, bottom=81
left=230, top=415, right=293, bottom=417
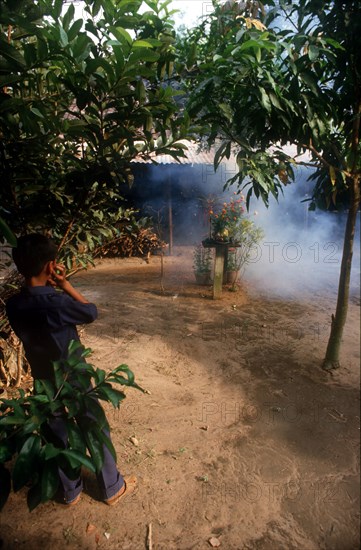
left=323, top=176, right=360, bottom=370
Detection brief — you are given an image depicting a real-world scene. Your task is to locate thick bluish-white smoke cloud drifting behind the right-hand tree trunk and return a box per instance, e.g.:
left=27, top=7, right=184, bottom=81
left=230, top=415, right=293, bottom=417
left=245, top=171, right=360, bottom=298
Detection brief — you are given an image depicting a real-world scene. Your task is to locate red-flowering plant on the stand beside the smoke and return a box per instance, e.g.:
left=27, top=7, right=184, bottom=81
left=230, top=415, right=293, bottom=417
left=209, top=195, right=245, bottom=242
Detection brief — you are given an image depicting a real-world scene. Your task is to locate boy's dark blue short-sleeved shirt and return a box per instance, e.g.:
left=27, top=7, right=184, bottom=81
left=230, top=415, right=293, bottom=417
left=6, top=286, right=97, bottom=379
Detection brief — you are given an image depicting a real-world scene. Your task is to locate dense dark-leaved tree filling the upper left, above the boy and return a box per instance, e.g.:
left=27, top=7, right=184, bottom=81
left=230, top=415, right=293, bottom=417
left=0, top=0, right=184, bottom=264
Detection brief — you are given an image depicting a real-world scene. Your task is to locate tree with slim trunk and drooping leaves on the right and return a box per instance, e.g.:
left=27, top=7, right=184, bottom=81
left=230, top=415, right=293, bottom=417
left=179, top=0, right=361, bottom=369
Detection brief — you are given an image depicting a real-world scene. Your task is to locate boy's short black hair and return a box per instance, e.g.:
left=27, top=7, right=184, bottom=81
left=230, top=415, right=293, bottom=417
left=12, top=233, right=58, bottom=279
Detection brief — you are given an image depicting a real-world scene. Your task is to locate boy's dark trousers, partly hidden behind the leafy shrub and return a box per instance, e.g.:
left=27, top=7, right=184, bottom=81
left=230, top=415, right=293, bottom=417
left=48, top=412, right=124, bottom=502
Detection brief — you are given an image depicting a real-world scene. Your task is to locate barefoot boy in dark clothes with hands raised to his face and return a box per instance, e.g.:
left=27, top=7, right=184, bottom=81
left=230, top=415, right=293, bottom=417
left=6, top=233, right=136, bottom=505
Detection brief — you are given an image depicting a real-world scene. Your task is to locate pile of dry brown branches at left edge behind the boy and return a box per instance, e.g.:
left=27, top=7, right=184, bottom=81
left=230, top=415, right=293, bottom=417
left=0, top=271, right=29, bottom=391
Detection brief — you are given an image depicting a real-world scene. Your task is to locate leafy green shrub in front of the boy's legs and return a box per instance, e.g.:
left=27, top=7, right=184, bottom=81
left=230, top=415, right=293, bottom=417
left=0, top=341, right=143, bottom=510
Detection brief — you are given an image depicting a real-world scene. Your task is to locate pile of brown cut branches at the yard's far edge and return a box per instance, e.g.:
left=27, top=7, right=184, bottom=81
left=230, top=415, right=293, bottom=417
left=96, top=228, right=167, bottom=261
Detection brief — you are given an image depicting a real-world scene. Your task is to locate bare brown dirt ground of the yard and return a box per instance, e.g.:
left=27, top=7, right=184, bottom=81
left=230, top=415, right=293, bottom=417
left=0, top=247, right=360, bottom=550
